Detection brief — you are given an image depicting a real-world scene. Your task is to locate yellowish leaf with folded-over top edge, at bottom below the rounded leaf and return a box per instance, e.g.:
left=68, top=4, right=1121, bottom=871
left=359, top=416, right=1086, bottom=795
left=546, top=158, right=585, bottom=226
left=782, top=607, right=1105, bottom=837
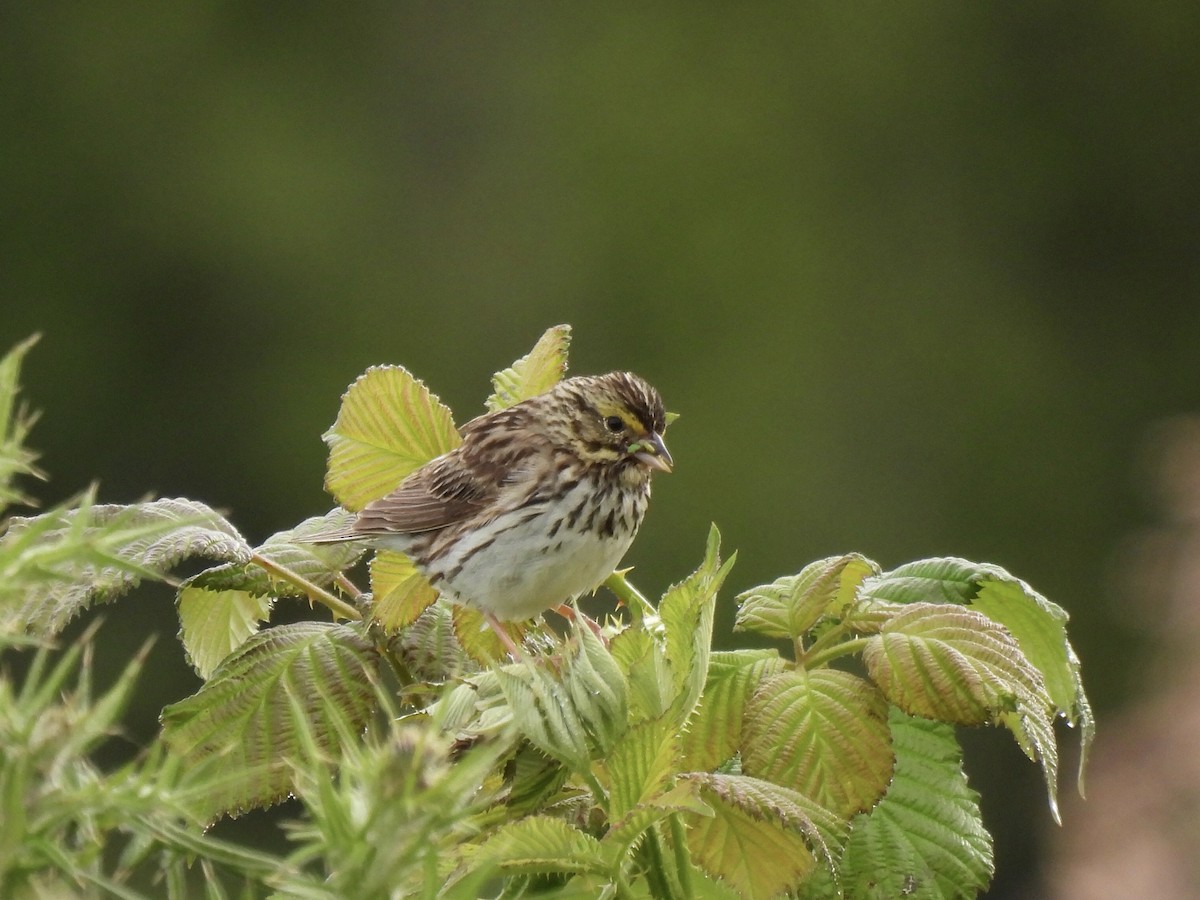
left=684, top=774, right=824, bottom=900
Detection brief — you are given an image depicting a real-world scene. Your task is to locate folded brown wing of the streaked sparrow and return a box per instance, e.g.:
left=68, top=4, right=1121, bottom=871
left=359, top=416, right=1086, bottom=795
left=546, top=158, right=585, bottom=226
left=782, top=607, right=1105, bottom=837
left=354, top=452, right=499, bottom=535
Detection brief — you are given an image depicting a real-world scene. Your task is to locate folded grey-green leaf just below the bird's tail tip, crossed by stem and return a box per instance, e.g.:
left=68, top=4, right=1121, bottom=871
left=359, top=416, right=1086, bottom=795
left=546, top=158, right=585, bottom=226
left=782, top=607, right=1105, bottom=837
left=186, top=509, right=366, bottom=598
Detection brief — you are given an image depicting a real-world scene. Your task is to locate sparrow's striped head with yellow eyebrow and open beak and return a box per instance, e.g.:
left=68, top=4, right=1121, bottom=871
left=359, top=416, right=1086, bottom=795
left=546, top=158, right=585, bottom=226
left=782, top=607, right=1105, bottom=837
left=551, top=372, right=673, bottom=474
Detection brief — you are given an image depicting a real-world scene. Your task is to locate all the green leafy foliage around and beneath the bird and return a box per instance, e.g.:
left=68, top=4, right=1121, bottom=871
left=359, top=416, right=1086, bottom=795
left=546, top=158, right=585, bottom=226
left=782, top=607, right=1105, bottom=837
left=0, top=326, right=1093, bottom=898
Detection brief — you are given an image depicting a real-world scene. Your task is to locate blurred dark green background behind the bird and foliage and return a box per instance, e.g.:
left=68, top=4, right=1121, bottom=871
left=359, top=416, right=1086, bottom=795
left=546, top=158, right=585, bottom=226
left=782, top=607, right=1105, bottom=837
left=0, top=0, right=1200, bottom=896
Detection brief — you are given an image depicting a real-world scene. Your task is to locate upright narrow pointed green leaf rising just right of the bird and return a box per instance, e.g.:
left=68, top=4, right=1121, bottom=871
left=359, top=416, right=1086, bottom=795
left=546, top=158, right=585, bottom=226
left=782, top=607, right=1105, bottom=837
left=659, top=526, right=737, bottom=725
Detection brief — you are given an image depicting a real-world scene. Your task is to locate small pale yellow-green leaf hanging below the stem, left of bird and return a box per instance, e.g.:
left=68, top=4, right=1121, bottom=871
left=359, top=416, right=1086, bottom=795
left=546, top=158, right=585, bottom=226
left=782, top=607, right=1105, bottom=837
left=176, top=587, right=272, bottom=679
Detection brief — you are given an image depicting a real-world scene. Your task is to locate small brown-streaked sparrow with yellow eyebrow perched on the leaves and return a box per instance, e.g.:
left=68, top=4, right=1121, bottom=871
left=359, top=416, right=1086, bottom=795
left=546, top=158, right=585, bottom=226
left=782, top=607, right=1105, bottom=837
left=316, top=372, right=674, bottom=656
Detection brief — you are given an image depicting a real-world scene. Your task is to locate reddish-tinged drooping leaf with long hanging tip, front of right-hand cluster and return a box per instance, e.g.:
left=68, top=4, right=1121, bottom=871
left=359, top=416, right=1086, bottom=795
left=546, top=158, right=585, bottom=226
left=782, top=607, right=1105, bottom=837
left=863, top=604, right=1058, bottom=820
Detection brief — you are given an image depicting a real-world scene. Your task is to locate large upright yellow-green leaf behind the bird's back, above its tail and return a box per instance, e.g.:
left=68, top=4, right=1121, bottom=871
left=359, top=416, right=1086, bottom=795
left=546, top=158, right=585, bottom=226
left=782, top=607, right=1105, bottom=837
left=323, top=366, right=461, bottom=511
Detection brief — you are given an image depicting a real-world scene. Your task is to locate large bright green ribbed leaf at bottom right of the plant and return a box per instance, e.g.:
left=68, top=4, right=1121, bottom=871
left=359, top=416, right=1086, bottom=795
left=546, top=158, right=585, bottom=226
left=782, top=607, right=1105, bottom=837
left=840, top=709, right=992, bottom=900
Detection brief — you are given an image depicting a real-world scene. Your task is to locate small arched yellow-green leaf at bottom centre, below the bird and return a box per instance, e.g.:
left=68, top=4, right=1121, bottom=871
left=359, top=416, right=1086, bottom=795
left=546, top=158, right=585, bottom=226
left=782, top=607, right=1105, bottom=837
left=472, top=816, right=607, bottom=874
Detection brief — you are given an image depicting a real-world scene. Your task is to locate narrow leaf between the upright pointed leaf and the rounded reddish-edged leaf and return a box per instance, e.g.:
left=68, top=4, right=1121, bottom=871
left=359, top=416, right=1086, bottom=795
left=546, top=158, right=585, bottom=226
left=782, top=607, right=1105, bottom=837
left=683, top=650, right=786, bottom=772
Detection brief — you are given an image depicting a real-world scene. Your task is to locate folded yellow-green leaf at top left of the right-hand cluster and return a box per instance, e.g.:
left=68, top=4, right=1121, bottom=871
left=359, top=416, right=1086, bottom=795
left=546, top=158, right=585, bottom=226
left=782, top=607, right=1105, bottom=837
left=733, top=553, right=880, bottom=641
